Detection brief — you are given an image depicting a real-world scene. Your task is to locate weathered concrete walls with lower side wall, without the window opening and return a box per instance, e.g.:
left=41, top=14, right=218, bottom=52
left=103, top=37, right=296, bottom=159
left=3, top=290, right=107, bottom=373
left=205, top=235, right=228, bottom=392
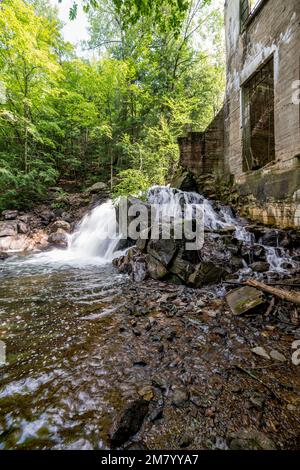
left=179, top=0, right=300, bottom=228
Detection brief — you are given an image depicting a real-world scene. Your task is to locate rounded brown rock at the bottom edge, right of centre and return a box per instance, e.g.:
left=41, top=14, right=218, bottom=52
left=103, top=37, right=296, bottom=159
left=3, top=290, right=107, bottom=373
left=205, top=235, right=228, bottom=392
left=229, top=429, right=276, bottom=450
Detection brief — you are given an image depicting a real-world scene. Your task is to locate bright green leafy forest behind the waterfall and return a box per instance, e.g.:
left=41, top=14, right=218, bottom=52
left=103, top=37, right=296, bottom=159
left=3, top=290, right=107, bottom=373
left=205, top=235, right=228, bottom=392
left=0, top=0, right=224, bottom=210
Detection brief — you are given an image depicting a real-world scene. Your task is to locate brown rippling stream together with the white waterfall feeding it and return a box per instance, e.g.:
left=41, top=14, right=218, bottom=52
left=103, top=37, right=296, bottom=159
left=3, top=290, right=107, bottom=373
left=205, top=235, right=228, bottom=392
left=0, top=185, right=300, bottom=449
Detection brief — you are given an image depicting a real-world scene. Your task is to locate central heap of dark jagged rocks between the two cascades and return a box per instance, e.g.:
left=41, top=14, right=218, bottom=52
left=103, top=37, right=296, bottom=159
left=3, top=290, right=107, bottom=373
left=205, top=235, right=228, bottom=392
left=114, top=217, right=242, bottom=288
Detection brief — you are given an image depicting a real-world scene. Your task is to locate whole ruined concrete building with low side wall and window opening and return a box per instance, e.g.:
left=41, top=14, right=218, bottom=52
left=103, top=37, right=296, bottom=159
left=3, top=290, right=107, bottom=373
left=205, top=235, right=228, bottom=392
left=179, top=0, right=300, bottom=227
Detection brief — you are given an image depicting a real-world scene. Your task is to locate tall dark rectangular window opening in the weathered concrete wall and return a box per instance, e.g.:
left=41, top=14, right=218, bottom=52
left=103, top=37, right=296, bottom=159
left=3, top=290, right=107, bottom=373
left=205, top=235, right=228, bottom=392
left=243, top=58, right=275, bottom=171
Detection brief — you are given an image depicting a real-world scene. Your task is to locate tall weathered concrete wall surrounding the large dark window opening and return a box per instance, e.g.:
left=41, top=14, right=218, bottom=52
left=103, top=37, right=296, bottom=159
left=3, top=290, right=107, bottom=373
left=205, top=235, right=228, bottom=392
left=224, top=0, right=300, bottom=226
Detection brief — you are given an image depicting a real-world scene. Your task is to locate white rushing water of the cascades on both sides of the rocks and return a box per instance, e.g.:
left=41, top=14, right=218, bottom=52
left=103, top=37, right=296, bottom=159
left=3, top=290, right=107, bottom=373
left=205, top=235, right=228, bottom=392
left=14, top=186, right=290, bottom=272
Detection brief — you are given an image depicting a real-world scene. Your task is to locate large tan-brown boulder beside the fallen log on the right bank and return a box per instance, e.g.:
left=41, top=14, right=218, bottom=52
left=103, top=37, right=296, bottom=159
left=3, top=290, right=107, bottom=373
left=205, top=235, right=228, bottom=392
left=226, top=286, right=267, bottom=316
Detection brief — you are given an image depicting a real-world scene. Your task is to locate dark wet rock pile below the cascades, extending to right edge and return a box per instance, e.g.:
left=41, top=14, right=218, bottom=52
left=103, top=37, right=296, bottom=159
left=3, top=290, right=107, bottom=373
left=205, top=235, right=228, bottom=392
left=114, top=198, right=300, bottom=288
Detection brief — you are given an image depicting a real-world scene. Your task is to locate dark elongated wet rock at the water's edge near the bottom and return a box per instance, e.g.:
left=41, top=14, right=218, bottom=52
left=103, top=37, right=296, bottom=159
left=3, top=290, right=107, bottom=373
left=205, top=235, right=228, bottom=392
left=109, top=398, right=149, bottom=447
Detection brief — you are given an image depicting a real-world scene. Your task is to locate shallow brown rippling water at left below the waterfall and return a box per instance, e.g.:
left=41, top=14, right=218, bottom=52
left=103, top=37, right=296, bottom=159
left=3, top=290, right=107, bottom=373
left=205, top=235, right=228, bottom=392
left=0, top=258, right=128, bottom=449
